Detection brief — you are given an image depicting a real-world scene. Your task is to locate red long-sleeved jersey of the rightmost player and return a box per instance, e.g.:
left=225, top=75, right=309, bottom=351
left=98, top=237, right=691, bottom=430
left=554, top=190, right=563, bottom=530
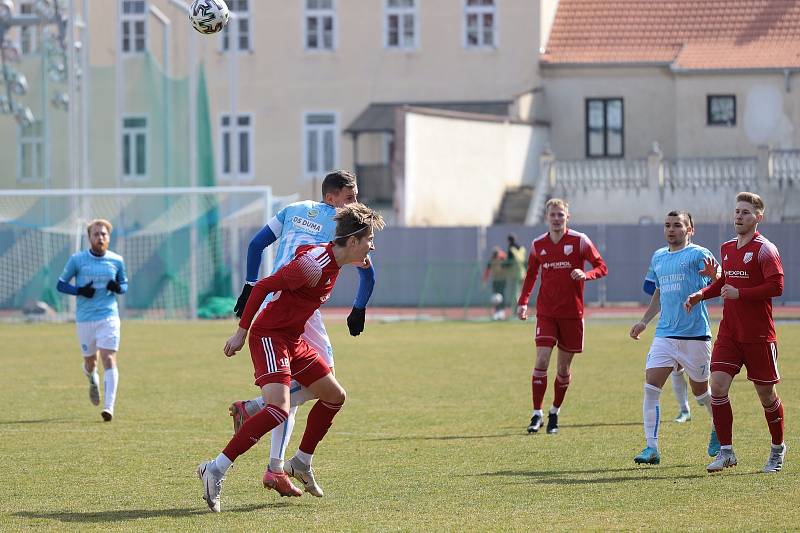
left=703, top=232, right=783, bottom=343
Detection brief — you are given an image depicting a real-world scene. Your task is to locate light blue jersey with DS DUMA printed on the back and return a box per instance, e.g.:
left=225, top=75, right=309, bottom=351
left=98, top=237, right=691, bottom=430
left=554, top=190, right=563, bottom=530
left=267, top=200, right=336, bottom=273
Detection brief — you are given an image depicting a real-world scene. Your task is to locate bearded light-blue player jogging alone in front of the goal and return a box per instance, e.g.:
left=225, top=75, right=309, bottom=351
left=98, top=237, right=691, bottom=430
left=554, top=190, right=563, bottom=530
left=57, top=219, right=128, bottom=422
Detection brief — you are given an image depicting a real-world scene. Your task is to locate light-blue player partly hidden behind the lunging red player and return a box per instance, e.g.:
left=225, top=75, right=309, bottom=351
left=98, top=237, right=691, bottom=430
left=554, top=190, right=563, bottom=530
left=229, top=170, right=375, bottom=497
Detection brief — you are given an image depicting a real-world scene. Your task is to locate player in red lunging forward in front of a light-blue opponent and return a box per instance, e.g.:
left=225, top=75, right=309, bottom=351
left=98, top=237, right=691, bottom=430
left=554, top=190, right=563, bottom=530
left=197, top=204, right=384, bottom=512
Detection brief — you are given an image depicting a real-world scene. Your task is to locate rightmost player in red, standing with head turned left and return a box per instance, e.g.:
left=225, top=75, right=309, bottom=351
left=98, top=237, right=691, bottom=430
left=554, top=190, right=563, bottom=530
left=685, top=192, right=786, bottom=472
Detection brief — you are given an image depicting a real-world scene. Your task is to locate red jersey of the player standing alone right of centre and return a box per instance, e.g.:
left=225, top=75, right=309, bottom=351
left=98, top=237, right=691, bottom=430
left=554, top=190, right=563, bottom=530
left=517, top=229, right=608, bottom=318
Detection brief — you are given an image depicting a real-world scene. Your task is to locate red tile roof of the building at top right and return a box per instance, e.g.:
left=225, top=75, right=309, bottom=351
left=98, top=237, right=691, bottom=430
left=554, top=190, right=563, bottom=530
left=539, top=0, right=800, bottom=69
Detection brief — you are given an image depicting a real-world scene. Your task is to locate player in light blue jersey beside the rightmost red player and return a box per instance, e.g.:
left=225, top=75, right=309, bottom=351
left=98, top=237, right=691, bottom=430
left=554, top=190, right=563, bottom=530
left=630, top=211, right=719, bottom=464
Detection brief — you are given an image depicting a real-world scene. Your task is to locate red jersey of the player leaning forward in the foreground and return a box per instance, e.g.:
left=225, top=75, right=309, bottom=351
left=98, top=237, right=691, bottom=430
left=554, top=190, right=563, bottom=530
left=239, top=243, right=339, bottom=339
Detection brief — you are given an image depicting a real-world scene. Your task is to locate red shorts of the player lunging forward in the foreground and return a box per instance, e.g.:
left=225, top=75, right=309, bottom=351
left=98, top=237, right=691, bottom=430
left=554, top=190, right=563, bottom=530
left=249, top=334, right=331, bottom=387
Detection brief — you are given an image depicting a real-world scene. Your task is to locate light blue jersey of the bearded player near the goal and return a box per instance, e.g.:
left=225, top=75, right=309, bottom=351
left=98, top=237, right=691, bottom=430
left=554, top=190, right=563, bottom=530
left=58, top=250, right=128, bottom=322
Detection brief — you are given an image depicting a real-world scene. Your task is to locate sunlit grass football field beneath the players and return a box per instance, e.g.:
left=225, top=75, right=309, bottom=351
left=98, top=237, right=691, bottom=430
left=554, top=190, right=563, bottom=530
left=0, top=321, right=800, bottom=531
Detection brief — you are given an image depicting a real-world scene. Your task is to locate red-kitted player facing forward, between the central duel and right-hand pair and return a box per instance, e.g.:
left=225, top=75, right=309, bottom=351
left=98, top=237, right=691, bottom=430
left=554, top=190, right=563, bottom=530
left=517, top=198, right=608, bottom=433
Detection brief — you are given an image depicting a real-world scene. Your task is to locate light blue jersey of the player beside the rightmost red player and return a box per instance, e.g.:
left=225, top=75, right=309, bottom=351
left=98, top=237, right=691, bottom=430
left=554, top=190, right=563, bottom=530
left=646, top=243, right=714, bottom=337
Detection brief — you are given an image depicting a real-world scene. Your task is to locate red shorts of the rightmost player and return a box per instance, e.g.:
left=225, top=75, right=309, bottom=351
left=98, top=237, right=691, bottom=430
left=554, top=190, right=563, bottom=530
left=711, top=337, right=781, bottom=385
